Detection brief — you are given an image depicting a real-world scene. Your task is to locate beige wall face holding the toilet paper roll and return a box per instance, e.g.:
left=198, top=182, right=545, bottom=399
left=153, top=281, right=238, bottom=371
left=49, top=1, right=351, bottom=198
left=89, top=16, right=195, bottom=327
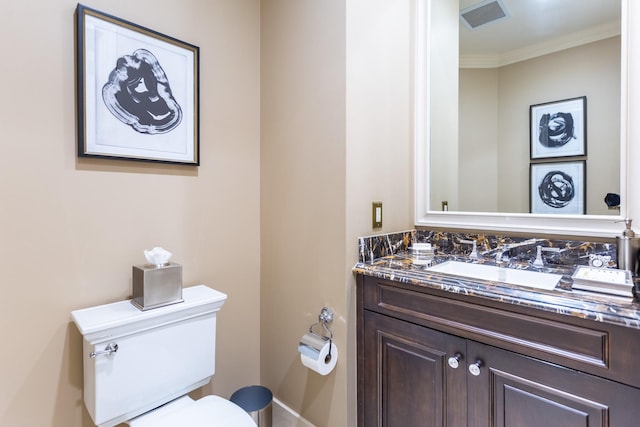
left=260, top=0, right=348, bottom=426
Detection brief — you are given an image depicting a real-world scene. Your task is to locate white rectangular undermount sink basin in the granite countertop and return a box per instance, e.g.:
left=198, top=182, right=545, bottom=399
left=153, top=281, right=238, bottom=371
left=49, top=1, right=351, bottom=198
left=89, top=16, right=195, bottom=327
left=427, top=261, right=562, bottom=290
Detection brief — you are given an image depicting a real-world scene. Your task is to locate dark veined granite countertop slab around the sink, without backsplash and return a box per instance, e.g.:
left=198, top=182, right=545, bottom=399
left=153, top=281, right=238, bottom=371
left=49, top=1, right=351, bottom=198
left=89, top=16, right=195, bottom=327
left=353, top=253, right=640, bottom=329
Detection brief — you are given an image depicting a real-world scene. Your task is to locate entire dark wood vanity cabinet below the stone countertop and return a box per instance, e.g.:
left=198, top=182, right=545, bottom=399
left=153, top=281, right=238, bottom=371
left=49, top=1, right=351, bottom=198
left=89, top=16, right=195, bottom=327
left=358, top=275, right=640, bottom=427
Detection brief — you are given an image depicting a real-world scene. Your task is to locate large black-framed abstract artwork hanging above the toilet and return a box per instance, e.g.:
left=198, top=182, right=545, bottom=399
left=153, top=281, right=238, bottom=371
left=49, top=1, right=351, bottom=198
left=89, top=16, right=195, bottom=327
left=76, top=4, right=200, bottom=166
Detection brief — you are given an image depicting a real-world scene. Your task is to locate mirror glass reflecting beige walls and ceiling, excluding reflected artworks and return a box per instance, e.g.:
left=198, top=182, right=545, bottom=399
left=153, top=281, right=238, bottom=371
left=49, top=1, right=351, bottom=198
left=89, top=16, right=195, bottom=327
left=425, top=0, right=621, bottom=216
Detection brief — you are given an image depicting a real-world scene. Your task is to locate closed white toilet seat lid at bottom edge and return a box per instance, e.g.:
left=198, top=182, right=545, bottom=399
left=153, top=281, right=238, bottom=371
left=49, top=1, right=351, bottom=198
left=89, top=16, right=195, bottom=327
left=129, top=395, right=256, bottom=427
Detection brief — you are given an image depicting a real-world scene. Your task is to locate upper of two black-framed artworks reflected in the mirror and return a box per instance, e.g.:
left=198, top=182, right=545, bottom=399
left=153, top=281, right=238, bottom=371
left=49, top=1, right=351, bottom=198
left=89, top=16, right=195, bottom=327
left=529, top=96, right=587, bottom=160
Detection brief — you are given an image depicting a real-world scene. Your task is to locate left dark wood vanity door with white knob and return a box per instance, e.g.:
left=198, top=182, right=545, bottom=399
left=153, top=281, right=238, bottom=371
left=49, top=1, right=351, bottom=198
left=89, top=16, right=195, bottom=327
left=358, top=311, right=468, bottom=427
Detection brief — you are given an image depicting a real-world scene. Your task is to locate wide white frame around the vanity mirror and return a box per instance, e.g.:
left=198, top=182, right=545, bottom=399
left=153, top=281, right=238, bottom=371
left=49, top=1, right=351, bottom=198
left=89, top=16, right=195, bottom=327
left=414, top=0, right=640, bottom=237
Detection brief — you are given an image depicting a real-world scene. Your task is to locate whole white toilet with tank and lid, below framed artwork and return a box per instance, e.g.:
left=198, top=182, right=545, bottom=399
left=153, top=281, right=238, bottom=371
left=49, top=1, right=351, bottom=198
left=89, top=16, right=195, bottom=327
left=71, top=285, right=256, bottom=427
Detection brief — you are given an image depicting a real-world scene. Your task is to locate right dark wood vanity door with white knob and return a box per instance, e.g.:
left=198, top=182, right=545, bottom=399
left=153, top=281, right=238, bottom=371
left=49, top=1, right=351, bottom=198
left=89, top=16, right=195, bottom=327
left=467, top=341, right=640, bottom=427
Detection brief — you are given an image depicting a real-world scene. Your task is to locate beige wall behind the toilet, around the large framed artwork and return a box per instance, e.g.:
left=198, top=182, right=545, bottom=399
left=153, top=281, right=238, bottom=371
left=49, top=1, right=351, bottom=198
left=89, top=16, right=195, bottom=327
left=0, top=0, right=260, bottom=427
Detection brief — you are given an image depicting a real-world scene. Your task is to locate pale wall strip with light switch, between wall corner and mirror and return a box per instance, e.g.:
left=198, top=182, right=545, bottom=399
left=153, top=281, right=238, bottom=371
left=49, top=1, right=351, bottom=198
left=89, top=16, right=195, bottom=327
left=344, top=0, right=416, bottom=426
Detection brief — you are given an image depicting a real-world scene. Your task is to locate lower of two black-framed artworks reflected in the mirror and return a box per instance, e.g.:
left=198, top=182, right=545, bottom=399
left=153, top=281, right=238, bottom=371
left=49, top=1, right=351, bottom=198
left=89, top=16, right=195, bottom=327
left=530, top=160, right=586, bottom=215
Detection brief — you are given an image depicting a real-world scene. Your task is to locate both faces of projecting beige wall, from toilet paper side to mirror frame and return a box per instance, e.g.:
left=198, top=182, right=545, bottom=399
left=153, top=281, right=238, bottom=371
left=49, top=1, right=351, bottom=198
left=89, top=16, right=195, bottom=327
left=261, top=0, right=413, bottom=426
